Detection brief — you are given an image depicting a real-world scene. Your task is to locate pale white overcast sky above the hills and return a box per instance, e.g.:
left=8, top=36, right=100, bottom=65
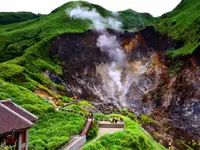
left=0, top=0, right=181, bottom=16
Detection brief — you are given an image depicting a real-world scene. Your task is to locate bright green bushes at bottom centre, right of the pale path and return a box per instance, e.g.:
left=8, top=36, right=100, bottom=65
left=84, top=114, right=165, bottom=150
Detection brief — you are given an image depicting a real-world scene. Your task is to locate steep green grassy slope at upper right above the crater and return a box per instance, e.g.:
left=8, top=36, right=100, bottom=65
left=155, top=0, right=200, bottom=57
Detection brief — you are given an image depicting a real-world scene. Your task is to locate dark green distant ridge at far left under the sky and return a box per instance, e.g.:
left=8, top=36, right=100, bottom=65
left=0, top=12, right=39, bottom=25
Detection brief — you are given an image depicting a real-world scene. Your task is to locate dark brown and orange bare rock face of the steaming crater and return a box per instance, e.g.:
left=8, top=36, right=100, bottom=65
left=50, top=27, right=200, bottom=149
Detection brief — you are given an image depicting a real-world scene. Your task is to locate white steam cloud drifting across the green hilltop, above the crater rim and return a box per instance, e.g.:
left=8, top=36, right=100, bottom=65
left=66, top=6, right=122, bottom=31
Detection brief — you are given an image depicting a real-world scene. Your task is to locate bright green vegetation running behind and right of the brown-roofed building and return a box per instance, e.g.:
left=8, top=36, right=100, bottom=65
left=0, top=80, right=85, bottom=150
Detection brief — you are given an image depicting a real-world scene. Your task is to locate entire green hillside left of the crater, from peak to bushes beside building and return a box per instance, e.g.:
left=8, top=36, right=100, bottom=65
left=0, top=2, right=159, bottom=150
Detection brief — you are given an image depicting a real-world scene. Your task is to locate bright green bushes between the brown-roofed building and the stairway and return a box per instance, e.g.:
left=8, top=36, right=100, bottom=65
left=29, top=111, right=85, bottom=150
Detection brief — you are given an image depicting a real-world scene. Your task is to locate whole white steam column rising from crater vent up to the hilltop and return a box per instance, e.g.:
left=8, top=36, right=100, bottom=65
left=66, top=6, right=134, bottom=107
